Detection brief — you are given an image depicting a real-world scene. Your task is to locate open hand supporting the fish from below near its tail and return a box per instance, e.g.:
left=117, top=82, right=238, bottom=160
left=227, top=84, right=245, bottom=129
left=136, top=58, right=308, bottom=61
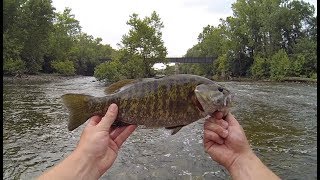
left=74, top=104, right=137, bottom=179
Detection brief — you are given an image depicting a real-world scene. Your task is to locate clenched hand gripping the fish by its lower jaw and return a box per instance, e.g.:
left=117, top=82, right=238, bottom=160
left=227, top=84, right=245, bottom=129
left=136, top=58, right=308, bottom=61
left=203, top=112, right=254, bottom=170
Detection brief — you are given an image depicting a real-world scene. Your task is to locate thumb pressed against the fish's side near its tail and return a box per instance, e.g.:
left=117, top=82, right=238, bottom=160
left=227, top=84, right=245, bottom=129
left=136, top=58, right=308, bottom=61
left=98, top=104, right=118, bottom=131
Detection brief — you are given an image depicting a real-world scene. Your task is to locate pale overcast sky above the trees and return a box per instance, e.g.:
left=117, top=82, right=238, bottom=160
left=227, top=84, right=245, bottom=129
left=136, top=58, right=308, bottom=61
left=53, top=0, right=317, bottom=57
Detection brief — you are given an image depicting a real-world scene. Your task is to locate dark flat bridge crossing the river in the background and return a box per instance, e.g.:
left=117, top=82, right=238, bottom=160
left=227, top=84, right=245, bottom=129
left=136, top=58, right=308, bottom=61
left=99, top=57, right=216, bottom=64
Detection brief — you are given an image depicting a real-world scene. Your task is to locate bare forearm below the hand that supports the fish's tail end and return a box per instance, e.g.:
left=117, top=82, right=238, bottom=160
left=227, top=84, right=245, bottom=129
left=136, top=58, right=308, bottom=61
left=38, top=152, right=100, bottom=180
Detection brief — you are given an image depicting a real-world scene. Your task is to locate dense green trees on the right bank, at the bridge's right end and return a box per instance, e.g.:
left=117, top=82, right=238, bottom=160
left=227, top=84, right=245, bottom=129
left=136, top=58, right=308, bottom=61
left=179, top=0, right=317, bottom=80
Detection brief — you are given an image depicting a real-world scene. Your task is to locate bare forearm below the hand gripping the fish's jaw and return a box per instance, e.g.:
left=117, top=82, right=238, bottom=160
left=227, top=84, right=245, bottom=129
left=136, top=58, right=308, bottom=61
left=229, top=152, right=280, bottom=180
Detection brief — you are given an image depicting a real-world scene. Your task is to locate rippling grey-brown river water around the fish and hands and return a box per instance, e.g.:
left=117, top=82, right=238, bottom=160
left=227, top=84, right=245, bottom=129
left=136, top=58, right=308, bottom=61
left=3, top=77, right=317, bottom=180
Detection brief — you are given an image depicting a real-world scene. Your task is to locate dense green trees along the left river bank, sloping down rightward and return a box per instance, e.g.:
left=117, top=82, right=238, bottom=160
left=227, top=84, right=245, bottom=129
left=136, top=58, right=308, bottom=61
left=3, top=0, right=115, bottom=75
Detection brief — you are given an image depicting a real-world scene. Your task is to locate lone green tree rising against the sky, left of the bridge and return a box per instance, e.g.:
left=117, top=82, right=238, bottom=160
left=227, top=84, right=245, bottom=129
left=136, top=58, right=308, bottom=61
left=120, top=11, right=167, bottom=77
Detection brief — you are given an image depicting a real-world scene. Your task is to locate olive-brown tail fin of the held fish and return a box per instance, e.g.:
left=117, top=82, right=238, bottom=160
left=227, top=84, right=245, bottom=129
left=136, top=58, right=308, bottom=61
left=62, top=94, right=93, bottom=131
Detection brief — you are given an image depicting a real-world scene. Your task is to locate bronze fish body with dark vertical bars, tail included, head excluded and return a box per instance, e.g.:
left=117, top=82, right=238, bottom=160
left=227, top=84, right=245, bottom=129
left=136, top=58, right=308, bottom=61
left=62, top=74, right=232, bottom=134
